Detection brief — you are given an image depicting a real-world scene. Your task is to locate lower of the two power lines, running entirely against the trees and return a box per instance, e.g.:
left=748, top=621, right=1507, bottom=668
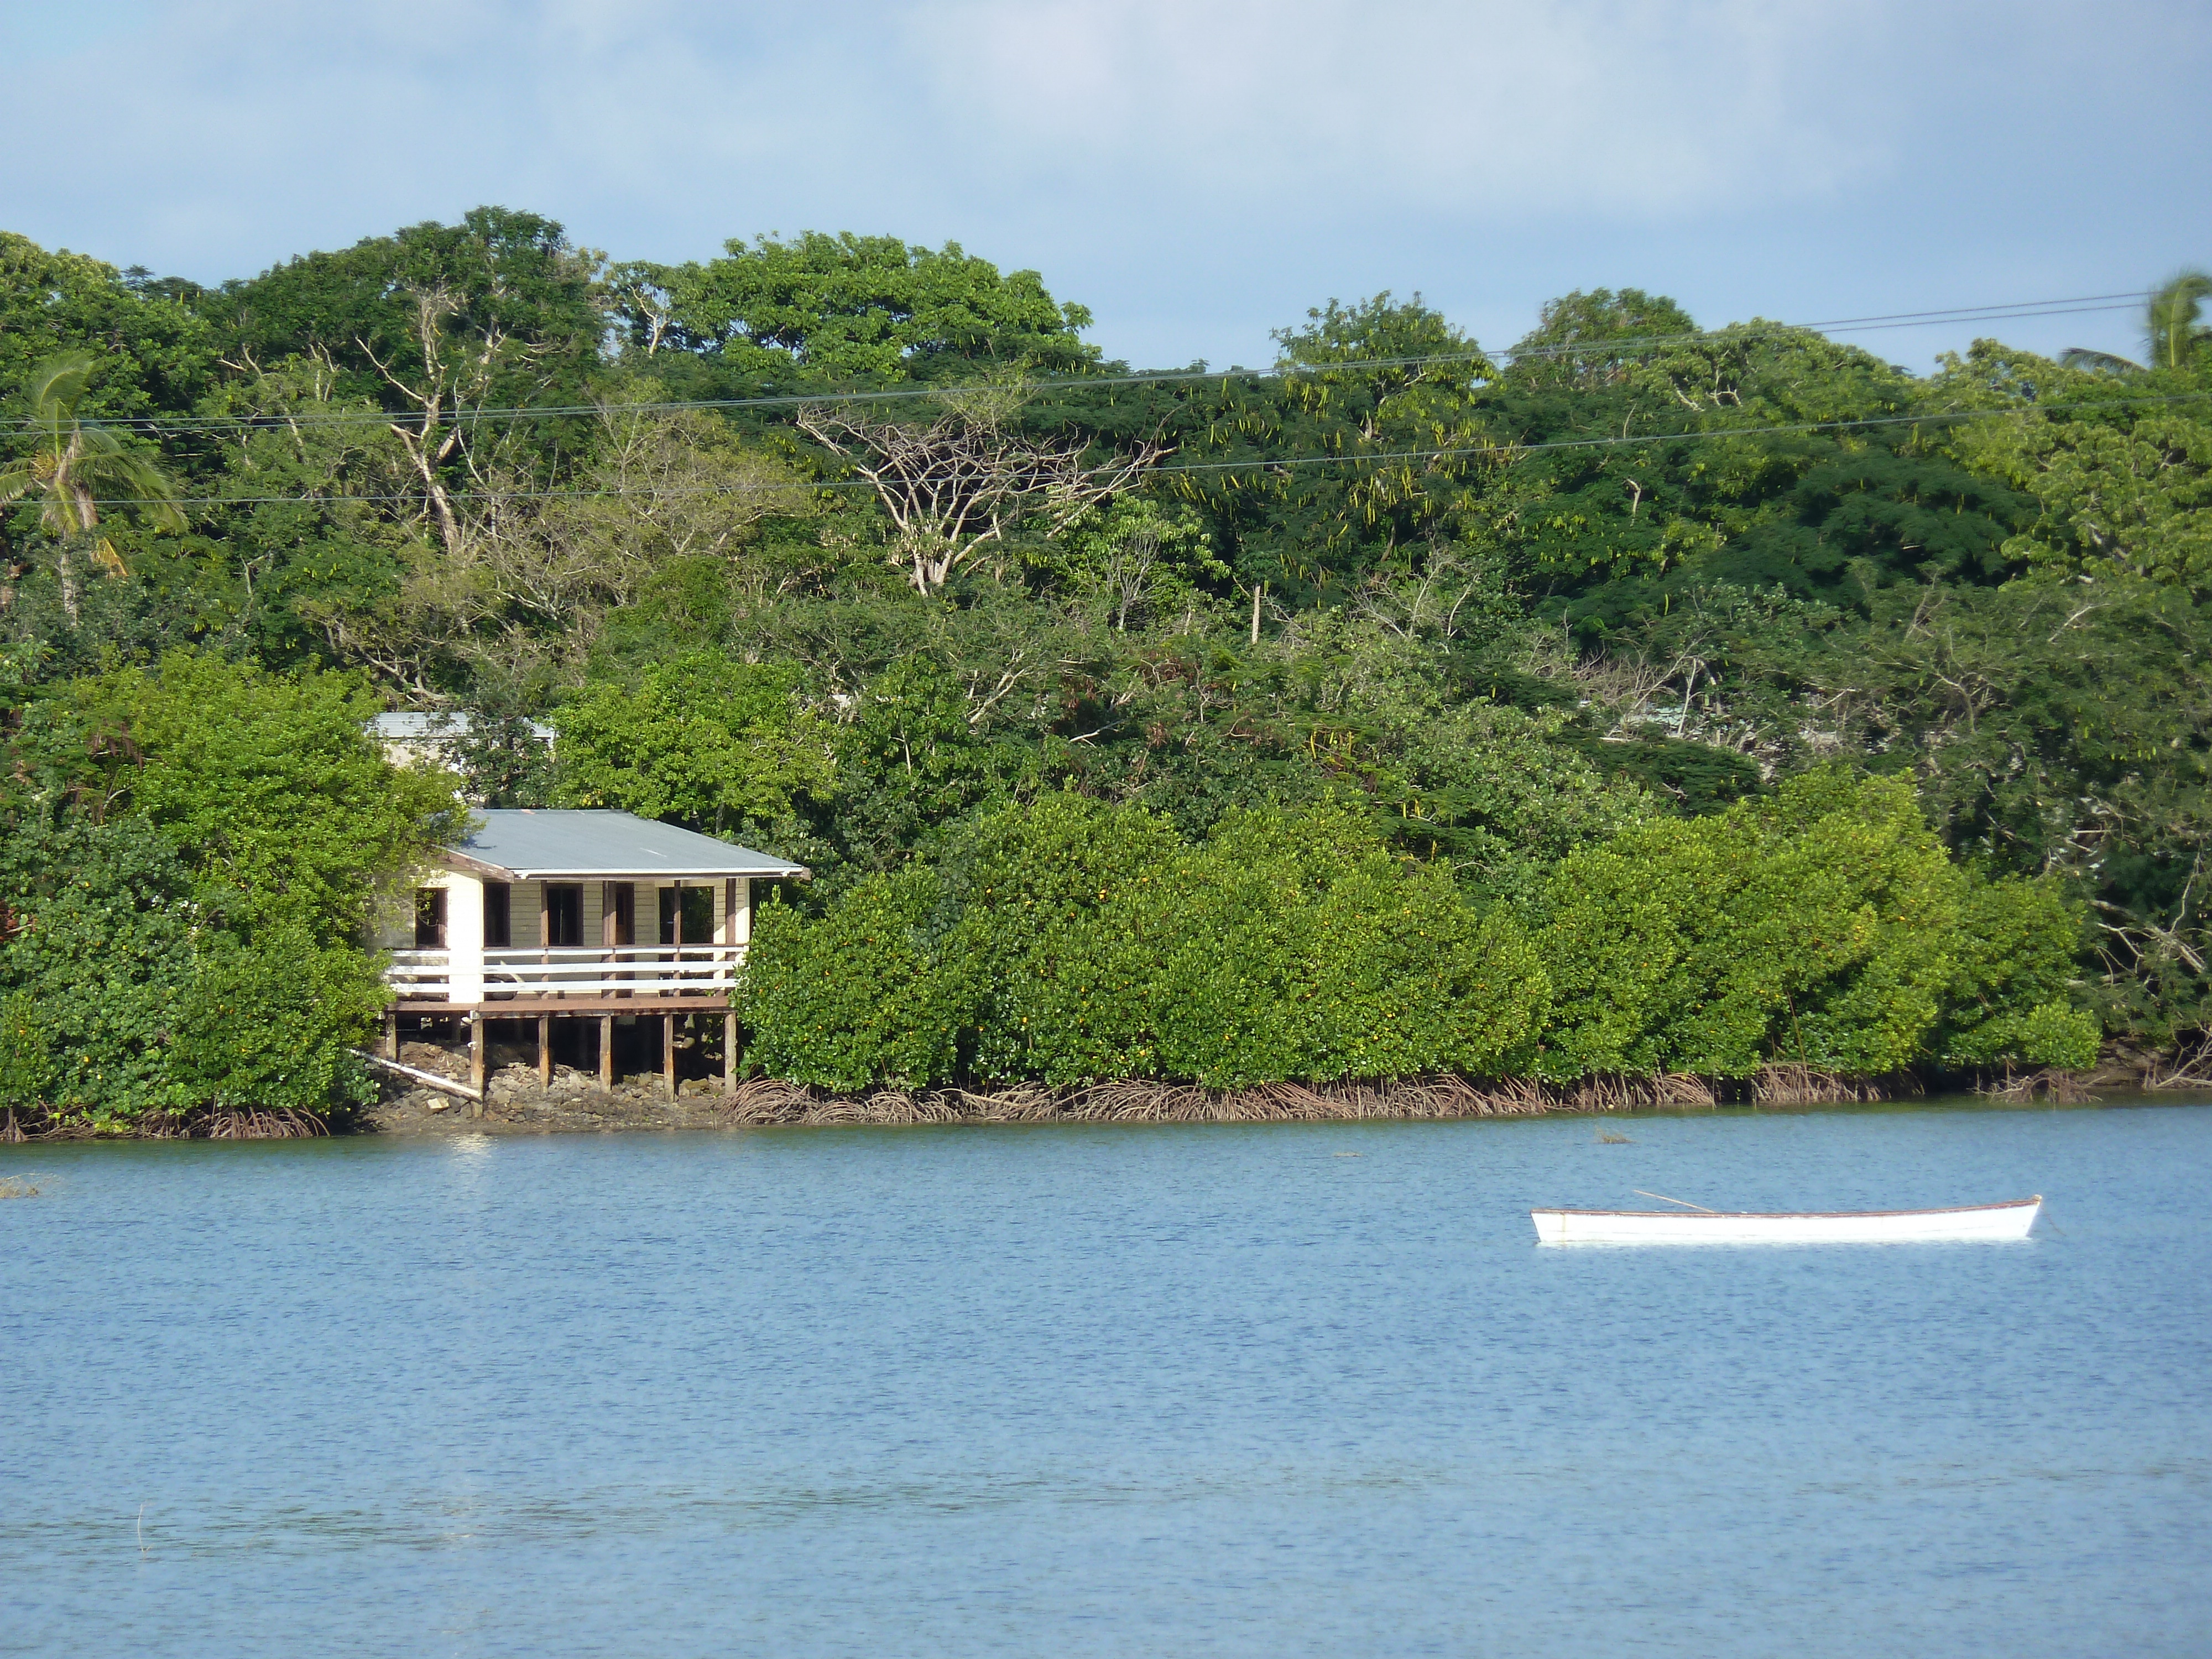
left=74, top=392, right=2212, bottom=507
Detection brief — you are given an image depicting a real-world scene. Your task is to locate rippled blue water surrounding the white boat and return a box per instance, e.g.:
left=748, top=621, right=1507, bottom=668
left=0, top=1106, right=2212, bottom=1659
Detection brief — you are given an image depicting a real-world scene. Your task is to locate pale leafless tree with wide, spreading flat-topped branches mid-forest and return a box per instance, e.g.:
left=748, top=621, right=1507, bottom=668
left=799, top=403, right=1172, bottom=593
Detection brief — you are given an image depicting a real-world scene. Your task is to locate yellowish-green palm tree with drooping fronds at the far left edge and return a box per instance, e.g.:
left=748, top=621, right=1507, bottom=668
left=0, top=354, right=184, bottom=622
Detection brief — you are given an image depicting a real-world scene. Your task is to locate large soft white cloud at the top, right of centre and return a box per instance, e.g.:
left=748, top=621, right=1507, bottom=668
left=907, top=0, right=1882, bottom=215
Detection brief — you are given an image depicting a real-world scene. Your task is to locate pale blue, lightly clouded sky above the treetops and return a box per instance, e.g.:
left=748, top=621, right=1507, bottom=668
left=0, top=0, right=2212, bottom=369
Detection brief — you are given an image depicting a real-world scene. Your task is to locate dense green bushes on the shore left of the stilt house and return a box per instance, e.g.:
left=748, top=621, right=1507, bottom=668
left=0, top=653, right=460, bottom=1130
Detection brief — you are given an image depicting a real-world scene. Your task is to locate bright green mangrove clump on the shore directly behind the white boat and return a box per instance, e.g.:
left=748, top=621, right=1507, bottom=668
left=1542, top=772, right=2097, bottom=1079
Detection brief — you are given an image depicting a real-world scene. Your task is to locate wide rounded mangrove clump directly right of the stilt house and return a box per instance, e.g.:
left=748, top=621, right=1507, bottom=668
left=743, top=796, right=1546, bottom=1088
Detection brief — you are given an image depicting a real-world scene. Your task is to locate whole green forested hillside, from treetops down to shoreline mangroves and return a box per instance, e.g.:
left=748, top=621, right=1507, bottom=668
left=0, top=208, right=2212, bottom=1130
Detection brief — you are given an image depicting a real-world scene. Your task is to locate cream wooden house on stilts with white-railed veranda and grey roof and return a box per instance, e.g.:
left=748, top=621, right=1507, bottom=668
left=378, top=810, right=807, bottom=1093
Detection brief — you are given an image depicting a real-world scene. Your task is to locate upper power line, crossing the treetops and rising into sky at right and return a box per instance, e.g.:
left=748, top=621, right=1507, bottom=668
left=13, top=290, right=2152, bottom=436
